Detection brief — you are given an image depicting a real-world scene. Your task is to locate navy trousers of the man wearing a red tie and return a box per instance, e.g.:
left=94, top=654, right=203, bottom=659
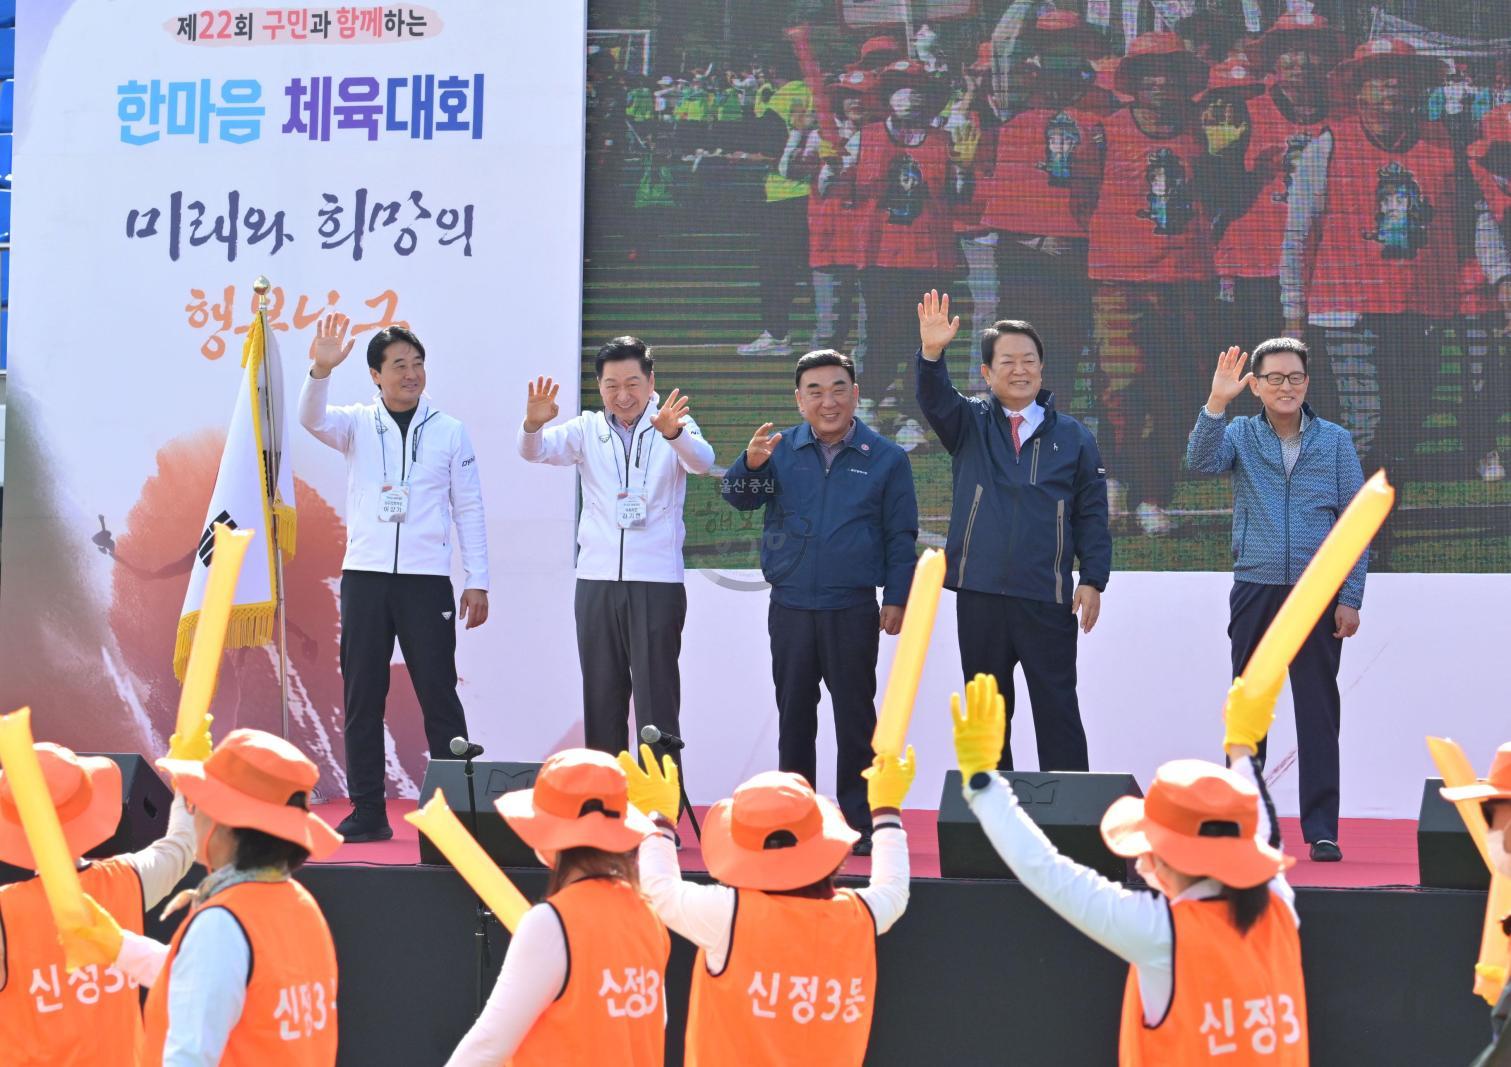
left=955, top=589, right=1091, bottom=771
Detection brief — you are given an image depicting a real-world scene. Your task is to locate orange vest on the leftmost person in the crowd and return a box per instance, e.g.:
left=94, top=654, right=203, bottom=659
left=0, top=858, right=142, bottom=1067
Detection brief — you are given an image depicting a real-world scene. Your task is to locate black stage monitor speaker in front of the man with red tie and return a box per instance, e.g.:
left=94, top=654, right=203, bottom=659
left=938, top=771, right=1144, bottom=881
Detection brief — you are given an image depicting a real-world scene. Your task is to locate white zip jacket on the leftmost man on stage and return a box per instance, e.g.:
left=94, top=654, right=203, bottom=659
left=299, top=375, right=488, bottom=591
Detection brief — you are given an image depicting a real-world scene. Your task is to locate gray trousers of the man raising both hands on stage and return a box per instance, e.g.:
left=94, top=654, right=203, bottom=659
left=576, top=579, right=688, bottom=763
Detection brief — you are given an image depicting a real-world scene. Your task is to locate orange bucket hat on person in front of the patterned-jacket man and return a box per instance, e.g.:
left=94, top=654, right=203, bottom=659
left=1102, top=760, right=1295, bottom=889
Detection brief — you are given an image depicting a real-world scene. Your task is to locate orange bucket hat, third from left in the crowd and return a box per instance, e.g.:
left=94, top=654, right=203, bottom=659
left=494, top=748, right=656, bottom=852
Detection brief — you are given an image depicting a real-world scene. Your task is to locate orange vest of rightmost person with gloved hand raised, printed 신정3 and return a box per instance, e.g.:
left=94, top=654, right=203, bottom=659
left=1118, top=895, right=1309, bottom=1067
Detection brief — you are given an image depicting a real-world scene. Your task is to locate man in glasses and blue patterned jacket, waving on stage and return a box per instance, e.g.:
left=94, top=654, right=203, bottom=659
left=1186, top=337, right=1369, bottom=861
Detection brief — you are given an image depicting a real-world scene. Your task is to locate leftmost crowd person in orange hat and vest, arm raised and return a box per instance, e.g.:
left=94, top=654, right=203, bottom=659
left=0, top=718, right=200, bottom=1067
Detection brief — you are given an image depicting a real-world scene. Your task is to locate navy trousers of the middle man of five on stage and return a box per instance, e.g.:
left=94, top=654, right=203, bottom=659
left=766, top=602, right=881, bottom=833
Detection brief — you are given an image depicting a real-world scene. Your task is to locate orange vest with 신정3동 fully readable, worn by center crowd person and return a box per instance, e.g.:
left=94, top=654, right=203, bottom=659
left=686, top=889, right=876, bottom=1067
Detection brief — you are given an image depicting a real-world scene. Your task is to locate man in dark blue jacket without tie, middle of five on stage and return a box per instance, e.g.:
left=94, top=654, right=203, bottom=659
left=722, top=349, right=919, bottom=852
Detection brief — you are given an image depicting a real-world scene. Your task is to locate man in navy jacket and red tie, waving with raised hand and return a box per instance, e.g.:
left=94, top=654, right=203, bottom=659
left=917, top=292, right=1112, bottom=771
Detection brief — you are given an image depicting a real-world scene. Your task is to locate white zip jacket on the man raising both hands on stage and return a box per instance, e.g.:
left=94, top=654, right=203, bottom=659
left=517, top=393, right=713, bottom=582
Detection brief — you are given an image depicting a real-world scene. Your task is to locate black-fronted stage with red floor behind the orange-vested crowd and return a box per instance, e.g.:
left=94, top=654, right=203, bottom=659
left=281, top=803, right=1488, bottom=1067
